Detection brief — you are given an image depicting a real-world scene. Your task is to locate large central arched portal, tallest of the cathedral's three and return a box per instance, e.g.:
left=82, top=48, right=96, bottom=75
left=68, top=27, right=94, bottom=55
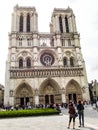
left=39, top=78, right=62, bottom=104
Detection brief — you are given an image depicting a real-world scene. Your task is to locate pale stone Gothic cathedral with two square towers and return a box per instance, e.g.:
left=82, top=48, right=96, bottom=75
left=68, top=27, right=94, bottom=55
left=4, top=5, right=89, bottom=106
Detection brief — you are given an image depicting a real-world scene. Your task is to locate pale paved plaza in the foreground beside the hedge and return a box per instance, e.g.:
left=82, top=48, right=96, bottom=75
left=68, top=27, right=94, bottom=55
left=0, top=106, right=98, bottom=130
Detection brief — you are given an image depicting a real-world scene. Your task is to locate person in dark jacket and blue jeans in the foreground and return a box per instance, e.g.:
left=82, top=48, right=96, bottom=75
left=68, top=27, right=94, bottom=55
left=77, top=101, right=84, bottom=127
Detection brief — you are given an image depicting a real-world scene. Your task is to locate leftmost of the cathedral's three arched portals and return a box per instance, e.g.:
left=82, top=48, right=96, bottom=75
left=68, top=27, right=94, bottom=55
left=15, top=83, right=34, bottom=107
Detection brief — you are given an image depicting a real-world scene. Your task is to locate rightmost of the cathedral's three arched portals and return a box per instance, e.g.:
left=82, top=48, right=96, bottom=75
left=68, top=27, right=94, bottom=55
left=66, top=80, right=82, bottom=103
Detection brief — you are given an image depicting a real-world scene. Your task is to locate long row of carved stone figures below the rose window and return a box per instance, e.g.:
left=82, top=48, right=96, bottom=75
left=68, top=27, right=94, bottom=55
left=10, top=67, right=83, bottom=78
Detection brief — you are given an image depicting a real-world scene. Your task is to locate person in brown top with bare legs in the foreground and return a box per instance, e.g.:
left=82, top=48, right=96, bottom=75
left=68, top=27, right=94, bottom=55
left=67, top=103, right=76, bottom=129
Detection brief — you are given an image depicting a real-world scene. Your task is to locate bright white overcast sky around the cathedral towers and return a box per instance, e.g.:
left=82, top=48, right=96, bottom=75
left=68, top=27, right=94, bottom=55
left=0, top=0, right=98, bottom=86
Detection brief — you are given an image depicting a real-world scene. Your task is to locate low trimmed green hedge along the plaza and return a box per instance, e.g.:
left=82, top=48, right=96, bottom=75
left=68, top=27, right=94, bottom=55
left=0, top=108, right=59, bottom=118
